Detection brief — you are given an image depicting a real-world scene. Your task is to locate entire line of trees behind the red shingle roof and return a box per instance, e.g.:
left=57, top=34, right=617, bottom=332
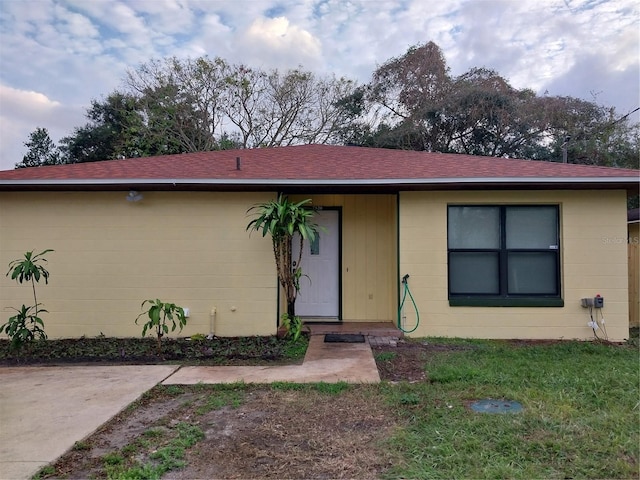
left=17, top=42, right=640, bottom=168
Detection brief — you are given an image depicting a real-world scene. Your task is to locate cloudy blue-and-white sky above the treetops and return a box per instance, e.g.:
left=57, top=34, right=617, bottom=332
left=0, top=0, right=640, bottom=170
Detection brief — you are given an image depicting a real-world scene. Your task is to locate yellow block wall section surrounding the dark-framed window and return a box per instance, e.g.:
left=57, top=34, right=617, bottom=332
left=399, top=191, right=629, bottom=340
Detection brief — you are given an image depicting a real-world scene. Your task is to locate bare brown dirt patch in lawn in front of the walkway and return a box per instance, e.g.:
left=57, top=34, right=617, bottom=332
left=164, top=387, right=394, bottom=480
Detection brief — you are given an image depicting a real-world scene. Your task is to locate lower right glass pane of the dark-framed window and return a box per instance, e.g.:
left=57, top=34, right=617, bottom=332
left=508, top=252, right=558, bottom=295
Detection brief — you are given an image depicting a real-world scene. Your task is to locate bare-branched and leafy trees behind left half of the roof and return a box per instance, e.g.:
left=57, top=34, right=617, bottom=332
left=48, top=56, right=355, bottom=163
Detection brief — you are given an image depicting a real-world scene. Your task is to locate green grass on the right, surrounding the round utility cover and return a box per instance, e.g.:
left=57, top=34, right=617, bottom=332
left=380, top=340, right=640, bottom=479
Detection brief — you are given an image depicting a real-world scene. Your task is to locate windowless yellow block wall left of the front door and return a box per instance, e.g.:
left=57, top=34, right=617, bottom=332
left=0, top=192, right=277, bottom=338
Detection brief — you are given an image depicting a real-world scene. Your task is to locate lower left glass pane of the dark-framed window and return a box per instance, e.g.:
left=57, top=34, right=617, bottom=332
left=449, top=252, right=500, bottom=295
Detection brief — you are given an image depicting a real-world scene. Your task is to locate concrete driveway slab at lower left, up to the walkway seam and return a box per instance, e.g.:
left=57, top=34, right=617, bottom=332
left=0, top=365, right=178, bottom=480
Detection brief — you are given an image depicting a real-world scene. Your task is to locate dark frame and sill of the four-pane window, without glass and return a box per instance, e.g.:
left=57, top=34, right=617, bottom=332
left=447, top=204, right=564, bottom=307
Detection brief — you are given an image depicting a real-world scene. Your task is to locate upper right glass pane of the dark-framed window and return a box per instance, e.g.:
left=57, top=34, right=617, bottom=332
left=505, top=206, right=558, bottom=250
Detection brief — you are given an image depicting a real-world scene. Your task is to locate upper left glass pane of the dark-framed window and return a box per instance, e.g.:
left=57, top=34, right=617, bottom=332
left=448, top=206, right=500, bottom=248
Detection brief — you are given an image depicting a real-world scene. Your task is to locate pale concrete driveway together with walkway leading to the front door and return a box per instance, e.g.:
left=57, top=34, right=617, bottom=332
left=0, top=332, right=390, bottom=480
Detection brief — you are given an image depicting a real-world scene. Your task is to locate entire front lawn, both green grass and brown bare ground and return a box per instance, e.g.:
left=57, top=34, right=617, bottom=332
left=33, top=338, right=640, bottom=479
